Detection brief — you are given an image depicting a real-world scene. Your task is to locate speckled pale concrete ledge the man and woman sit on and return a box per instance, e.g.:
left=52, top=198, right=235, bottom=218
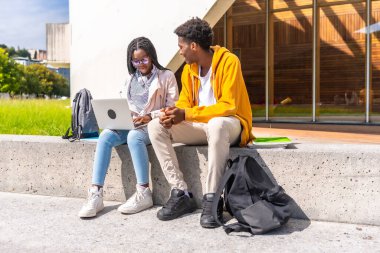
left=0, top=135, right=380, bottom=225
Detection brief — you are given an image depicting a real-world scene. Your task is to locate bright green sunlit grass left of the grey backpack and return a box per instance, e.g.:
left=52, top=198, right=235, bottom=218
left=0, top=99, right=71, bottom=136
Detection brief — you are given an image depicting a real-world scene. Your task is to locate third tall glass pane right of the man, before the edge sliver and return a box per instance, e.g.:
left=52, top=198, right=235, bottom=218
left=317, top=3, right=365, bottom=122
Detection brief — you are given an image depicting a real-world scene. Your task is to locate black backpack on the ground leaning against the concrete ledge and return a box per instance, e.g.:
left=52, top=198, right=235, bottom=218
left=212, top=156, right=291, bottom=234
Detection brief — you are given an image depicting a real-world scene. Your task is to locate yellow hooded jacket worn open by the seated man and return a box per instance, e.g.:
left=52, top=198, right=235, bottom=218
left=176, top=46, right=254, bottom=146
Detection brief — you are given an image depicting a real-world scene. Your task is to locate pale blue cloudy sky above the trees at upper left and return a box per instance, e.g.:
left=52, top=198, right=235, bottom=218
left=0, top=0, right=69, bottom=50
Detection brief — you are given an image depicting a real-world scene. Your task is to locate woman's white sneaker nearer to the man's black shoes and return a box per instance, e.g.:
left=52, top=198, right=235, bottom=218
left=117, top=184, right=153, bottom=214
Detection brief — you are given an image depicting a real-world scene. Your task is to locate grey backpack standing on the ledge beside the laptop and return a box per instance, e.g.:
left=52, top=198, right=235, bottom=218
left=62, top=89, right=99, bottom=141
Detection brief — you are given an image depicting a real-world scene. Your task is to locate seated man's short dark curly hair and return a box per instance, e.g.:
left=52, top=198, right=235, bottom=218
left=174, top=17, right=214, bottom=50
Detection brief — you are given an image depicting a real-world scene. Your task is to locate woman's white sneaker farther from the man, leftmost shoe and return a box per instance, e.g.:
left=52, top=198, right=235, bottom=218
left=78, top=187, right=104, bottom=218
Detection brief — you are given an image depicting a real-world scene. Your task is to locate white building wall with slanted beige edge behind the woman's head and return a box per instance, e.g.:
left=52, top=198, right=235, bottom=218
left=70, top=0, right=234, bottom=98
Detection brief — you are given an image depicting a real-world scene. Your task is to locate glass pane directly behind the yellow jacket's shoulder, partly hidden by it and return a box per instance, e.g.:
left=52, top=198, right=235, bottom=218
left=232, top=0, right=265, bottom=121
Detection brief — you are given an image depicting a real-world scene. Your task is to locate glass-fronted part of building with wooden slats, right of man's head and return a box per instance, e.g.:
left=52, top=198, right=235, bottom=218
left=214, top=0, right=380, bottom=124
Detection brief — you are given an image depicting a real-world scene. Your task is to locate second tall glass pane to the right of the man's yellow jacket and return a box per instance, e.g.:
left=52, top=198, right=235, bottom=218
left=270, top=8, right=313, bottom=121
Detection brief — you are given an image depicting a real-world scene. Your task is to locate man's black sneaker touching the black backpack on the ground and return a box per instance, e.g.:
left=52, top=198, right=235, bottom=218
left=200, top=193, right=223, bottom=228
